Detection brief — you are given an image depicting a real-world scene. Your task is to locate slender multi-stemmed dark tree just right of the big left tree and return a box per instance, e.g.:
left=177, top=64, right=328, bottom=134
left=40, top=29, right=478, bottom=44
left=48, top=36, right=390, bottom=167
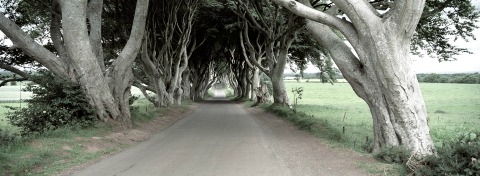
left=136, top=0, right=202, bottom=107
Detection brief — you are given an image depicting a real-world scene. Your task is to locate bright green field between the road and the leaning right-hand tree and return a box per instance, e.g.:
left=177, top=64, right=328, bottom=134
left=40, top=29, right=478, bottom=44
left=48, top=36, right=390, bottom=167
left=286, top=81, right=373, bottom=150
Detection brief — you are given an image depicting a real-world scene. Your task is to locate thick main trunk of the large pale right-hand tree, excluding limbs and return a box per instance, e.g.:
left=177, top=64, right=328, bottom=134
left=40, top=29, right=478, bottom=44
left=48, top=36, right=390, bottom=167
left=359, top=27, right=434, bottom=155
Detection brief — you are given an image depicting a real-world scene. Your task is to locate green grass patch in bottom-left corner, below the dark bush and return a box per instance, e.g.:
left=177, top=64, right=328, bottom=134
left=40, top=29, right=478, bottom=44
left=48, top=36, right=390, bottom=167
left=0, top=128, right=112, bottom=175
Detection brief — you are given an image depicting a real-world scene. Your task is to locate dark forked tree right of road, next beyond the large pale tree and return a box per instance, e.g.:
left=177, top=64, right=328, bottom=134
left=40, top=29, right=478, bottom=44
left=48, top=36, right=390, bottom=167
left=235, top=0, right=303, bottom=105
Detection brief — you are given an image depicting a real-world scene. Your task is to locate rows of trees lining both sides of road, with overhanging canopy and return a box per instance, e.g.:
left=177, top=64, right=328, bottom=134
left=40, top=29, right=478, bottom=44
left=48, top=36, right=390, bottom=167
left=0, top=0, right=479, bottom=156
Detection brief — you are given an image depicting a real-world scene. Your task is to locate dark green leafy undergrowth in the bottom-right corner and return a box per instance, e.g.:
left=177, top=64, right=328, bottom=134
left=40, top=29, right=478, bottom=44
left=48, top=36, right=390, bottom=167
left=413, top=132, right=480, bottom=175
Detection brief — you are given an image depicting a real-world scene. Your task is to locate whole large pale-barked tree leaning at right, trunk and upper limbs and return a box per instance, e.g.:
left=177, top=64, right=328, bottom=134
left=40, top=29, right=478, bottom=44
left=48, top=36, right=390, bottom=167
left=273, top=0, right=434, bottom=156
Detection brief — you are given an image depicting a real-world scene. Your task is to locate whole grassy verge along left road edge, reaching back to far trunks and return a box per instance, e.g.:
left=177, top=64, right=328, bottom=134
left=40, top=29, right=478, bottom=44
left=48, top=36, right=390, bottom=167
left=0, top=99, right=191, bottom=176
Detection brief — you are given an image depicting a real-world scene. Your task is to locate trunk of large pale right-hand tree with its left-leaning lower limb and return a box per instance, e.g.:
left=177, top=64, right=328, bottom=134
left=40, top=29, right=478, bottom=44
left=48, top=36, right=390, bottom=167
left=307, top=7, right=434, bottom=156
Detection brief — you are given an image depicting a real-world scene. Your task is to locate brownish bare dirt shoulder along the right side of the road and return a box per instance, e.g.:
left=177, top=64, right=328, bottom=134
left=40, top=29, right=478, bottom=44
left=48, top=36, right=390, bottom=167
left=245, top=107, right=384, bottom=176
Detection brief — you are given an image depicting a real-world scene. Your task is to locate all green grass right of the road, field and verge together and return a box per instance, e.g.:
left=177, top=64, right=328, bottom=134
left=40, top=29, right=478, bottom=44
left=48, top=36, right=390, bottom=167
left=253, top=80, right=480, bottom=175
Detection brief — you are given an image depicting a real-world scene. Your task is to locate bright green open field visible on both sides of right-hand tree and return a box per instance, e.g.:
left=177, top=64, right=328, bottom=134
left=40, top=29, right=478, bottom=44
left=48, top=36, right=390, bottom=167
left=286, top=80, right=480, bottom=149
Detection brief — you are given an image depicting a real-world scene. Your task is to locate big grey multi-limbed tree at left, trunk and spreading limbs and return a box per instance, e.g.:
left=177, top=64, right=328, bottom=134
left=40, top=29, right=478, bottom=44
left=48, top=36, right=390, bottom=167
left=0, top=0, right=149, bottom=127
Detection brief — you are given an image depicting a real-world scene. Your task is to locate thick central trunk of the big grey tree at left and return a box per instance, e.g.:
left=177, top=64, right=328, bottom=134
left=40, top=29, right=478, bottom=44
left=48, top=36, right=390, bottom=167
left=60, top=0, right=121, bottom=121
